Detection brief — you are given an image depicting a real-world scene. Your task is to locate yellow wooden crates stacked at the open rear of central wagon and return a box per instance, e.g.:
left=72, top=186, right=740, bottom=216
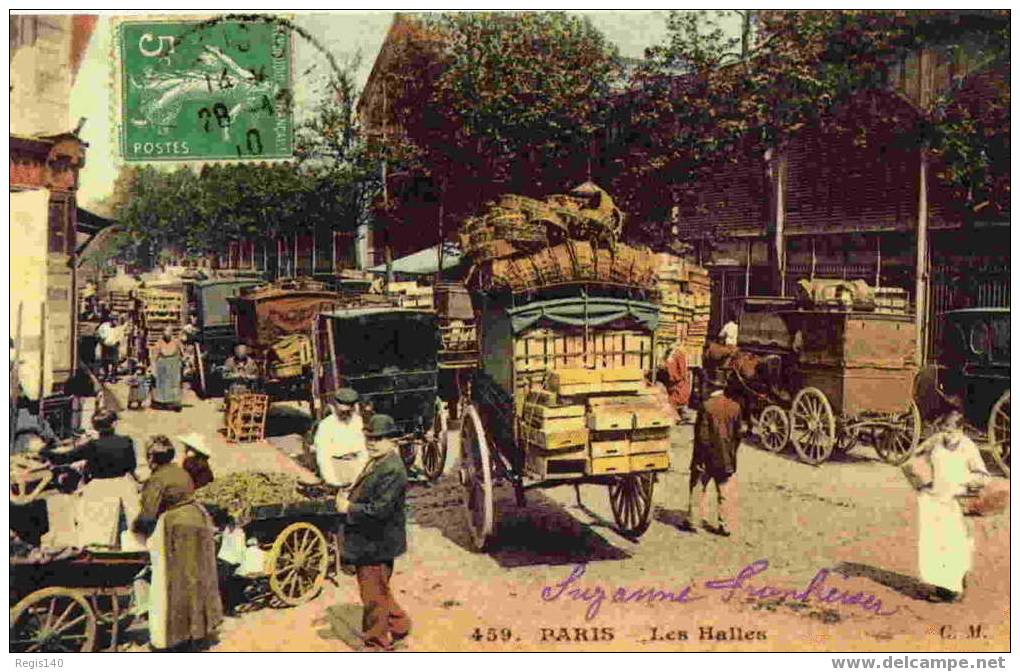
left=520, top=368, right=672, bottom=479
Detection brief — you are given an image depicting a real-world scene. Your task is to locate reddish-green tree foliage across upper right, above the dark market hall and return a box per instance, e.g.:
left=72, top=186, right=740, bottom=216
left=618, top=10, right=1009, bottom=223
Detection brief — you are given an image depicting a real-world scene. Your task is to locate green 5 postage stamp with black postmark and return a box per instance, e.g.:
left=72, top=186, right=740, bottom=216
left=118, top=19, right=294, bottom=161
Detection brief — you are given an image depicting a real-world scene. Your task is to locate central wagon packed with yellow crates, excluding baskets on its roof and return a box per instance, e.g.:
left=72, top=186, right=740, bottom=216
left=460, top=283, right=674, bottom=551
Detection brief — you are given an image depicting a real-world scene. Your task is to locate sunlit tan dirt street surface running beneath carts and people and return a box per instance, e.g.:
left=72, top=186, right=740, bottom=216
left=45, top=385, right=1010, bottom=652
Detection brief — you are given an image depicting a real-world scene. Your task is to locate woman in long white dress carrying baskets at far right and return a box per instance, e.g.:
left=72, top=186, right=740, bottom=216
left=917, top=401, right=989, bottom=602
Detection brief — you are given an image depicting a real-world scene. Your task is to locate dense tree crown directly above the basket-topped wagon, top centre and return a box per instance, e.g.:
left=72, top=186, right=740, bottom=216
left=384, top=12, right=619, bottom=226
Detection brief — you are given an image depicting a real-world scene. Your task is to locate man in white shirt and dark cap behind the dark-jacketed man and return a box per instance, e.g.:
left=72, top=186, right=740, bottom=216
left=312, top=387, right=368, bottom=488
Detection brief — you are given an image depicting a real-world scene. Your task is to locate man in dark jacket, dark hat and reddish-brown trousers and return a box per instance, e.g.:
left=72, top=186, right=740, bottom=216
left=337, top=414, right=411, bottom=651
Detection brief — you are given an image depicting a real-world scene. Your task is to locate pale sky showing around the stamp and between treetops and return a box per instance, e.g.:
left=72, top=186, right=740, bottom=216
left=70, top=10, right=685, bottom=214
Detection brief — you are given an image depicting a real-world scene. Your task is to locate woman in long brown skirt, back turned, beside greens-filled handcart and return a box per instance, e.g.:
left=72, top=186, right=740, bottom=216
left=132, top=435, right=223, bottom=650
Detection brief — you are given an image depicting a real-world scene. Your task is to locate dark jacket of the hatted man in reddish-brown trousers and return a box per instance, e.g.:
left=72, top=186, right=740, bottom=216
left=343, top=452, right=407, bottom=565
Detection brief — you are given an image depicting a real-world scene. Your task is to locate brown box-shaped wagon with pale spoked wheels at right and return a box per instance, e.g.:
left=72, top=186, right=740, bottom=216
left=742, top=309, right=921, bottom=464
